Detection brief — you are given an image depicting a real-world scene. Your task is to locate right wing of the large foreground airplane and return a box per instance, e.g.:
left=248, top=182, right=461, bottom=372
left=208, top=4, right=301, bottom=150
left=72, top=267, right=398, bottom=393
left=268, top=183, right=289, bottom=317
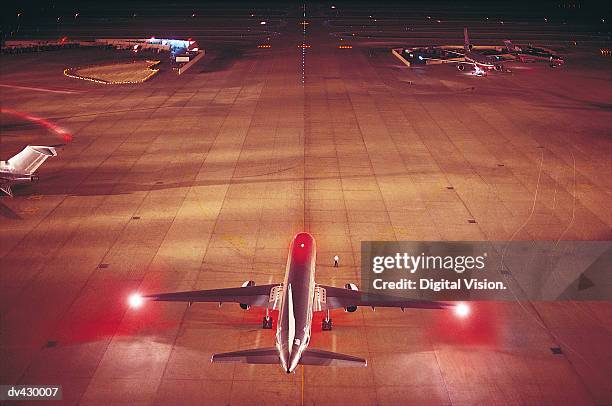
left=318, top=285, right=455, bottom=310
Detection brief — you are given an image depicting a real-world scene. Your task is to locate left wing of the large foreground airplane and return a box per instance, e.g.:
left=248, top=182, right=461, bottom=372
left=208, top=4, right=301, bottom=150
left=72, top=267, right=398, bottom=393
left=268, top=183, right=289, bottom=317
left=142, top=285, right=282, bottom=308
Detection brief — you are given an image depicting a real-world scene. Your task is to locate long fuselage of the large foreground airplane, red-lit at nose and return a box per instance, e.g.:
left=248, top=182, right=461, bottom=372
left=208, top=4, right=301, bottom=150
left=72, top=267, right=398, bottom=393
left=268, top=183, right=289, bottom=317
left=276, top=233, right=317, bottom=373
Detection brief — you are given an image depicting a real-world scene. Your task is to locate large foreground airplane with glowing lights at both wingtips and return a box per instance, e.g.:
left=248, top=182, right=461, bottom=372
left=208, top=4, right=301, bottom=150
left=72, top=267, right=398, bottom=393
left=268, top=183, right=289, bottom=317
left=128, top=232, right=469, bottom=373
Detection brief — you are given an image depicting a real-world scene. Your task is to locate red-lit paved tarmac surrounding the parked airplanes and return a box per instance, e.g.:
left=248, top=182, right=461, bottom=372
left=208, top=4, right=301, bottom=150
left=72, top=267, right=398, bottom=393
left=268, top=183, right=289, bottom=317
left=0, top=3, right=612, bottom=406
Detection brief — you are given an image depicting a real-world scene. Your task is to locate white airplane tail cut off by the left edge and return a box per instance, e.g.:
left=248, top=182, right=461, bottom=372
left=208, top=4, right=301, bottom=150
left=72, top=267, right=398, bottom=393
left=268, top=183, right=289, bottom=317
left=0, top=144, right=63, bottom=197
